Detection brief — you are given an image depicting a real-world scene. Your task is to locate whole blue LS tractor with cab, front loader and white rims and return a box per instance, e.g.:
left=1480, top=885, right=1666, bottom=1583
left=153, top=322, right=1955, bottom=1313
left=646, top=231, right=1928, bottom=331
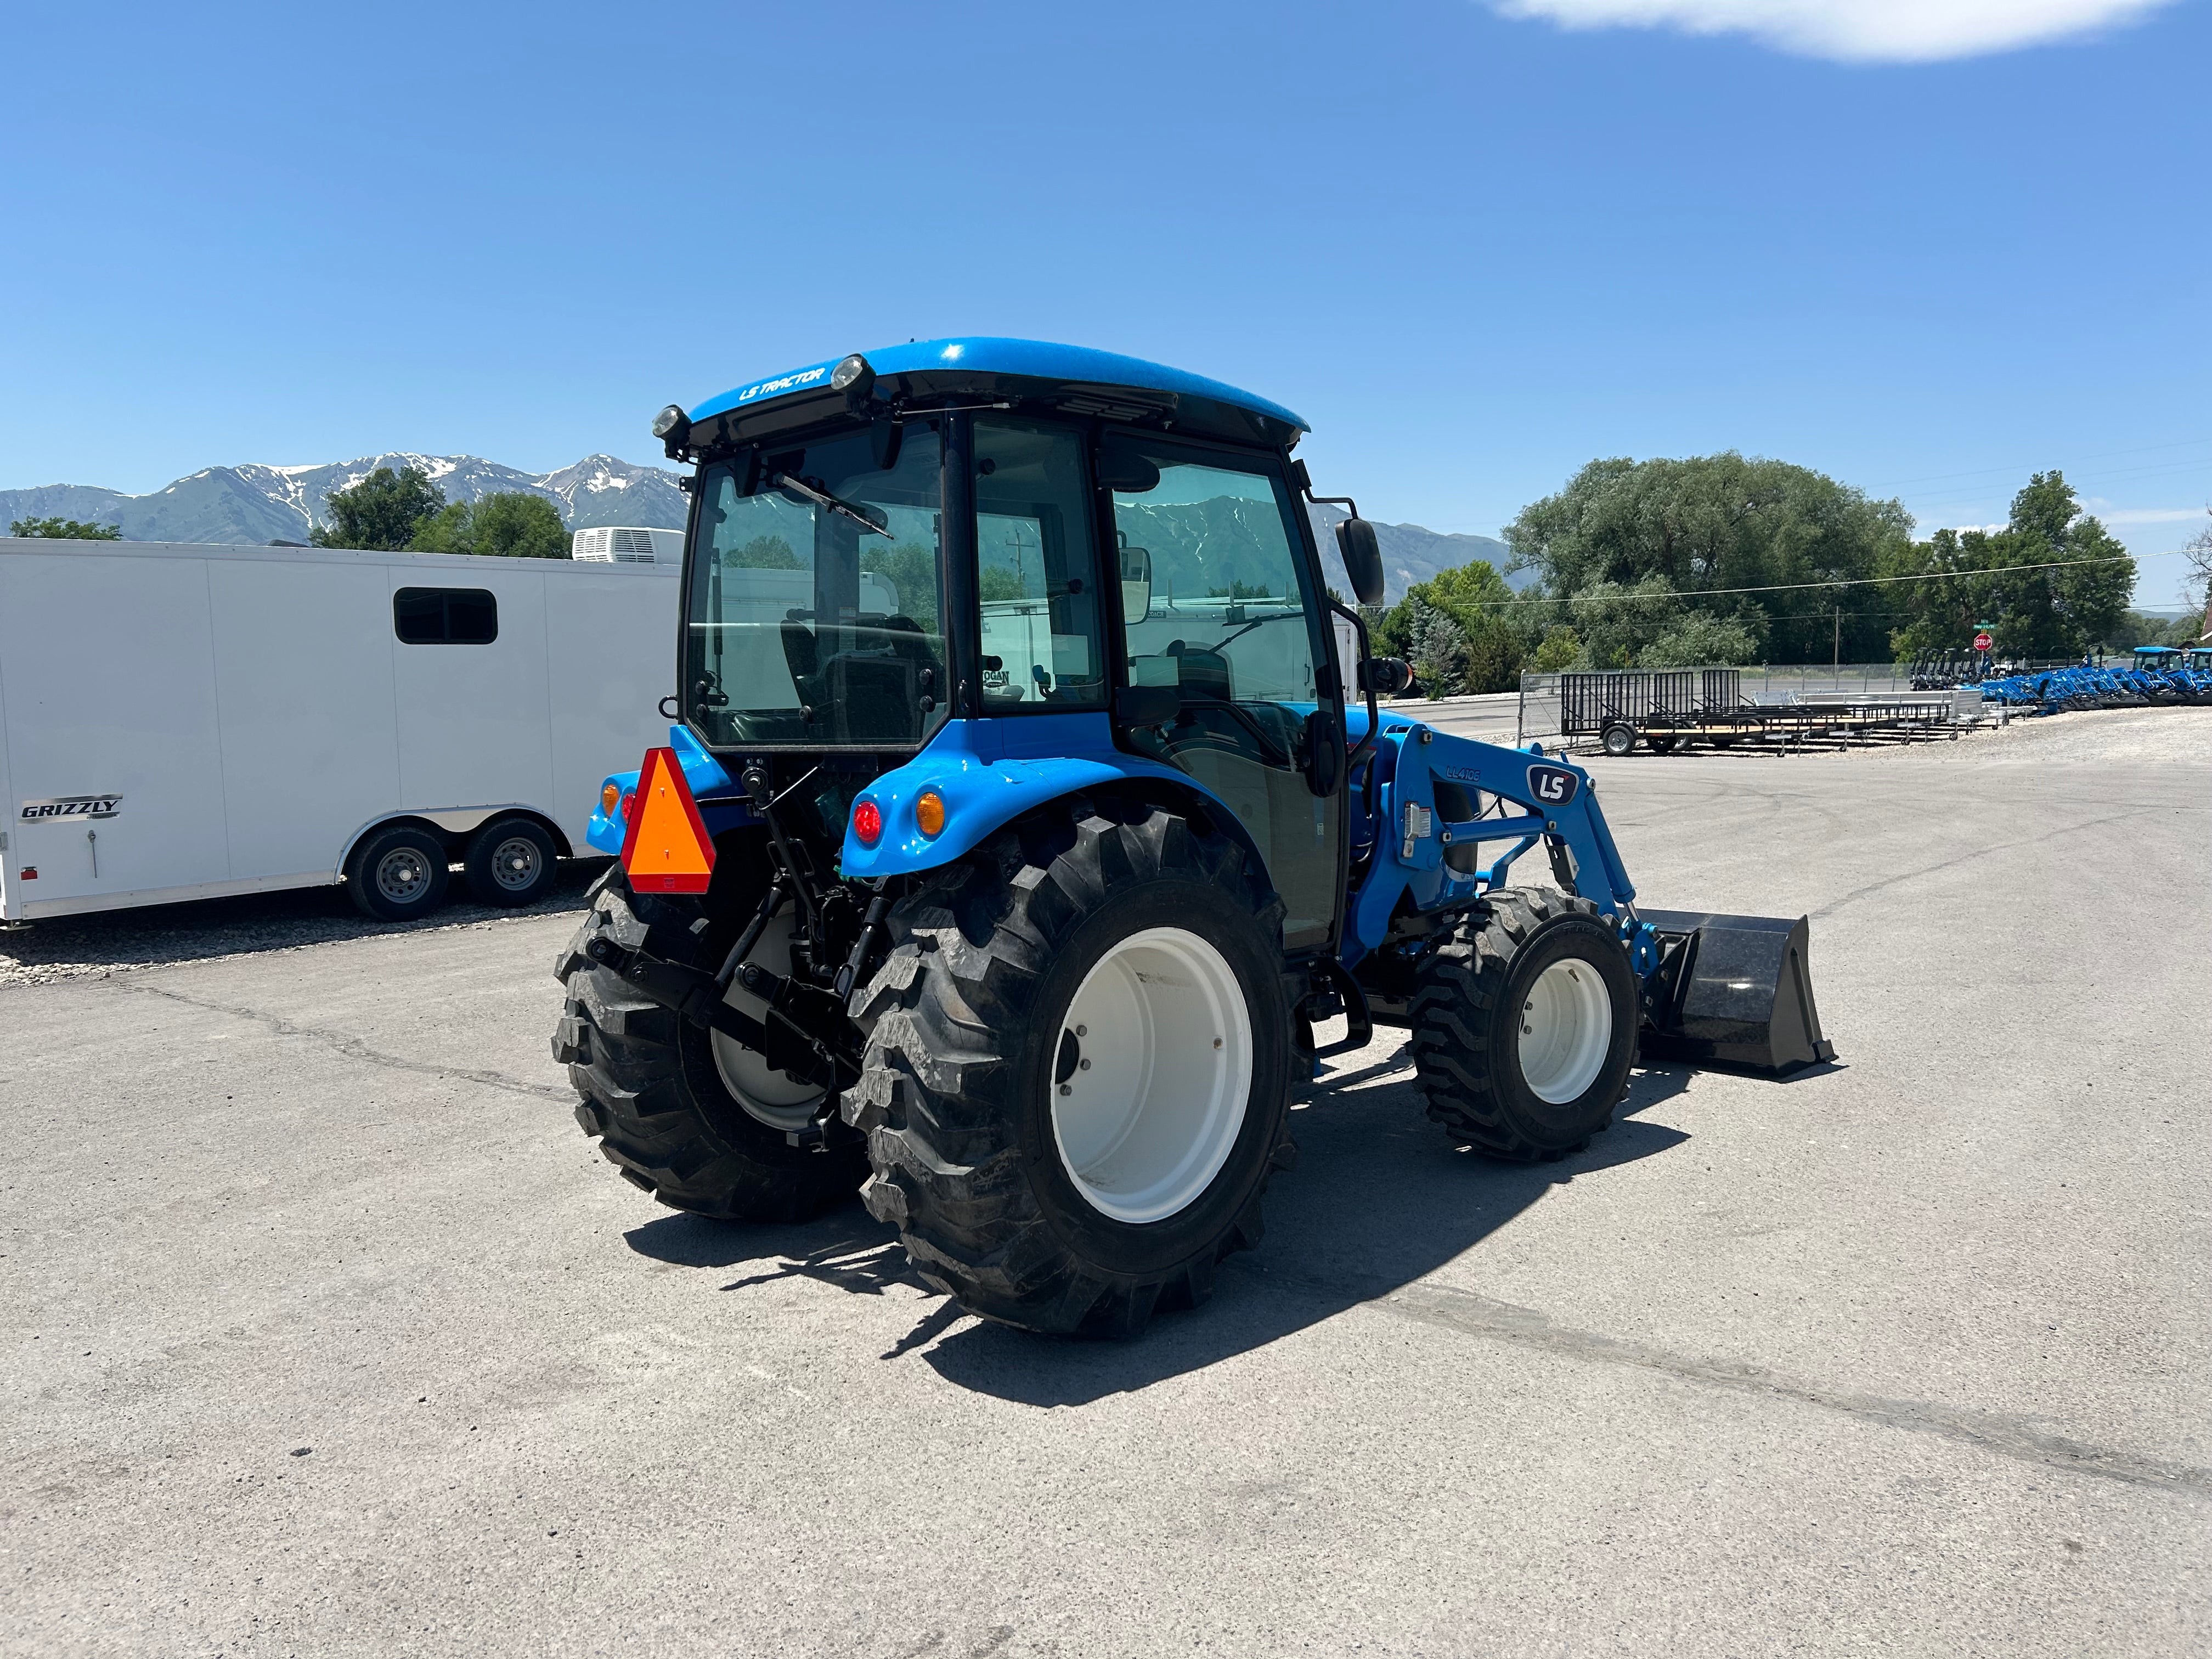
left=553, top=338, right=1831, bottom=1334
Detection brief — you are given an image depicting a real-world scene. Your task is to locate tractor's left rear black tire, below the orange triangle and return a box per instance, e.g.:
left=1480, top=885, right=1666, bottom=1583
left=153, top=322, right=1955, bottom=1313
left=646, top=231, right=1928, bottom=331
left=553, top=872, right=867, bottom=1221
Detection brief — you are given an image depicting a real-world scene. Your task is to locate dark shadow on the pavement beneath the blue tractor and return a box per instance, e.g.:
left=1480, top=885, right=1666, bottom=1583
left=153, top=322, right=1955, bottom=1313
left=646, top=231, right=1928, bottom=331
left=626, top=1033, right=1692, bottom=1407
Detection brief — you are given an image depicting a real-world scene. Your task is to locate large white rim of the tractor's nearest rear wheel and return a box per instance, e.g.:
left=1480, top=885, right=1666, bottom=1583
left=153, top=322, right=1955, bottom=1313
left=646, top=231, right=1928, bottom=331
left=1044, top=927, right=1252, bottom=1226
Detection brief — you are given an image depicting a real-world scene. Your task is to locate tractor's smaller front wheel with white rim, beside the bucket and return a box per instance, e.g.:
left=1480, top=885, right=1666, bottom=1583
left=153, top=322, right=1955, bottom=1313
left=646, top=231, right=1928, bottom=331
left=1411, top=889, right=1637, bottom=1161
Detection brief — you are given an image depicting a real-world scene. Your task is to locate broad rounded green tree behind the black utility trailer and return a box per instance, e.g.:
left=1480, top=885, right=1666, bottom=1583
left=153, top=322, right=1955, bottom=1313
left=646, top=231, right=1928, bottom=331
left=1504, top=452, right=1914, bottom=668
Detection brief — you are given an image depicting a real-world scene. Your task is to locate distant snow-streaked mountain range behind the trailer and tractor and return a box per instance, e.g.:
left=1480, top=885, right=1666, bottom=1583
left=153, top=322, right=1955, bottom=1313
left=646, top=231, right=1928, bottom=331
left=0, top=452, right=1533, bottom=602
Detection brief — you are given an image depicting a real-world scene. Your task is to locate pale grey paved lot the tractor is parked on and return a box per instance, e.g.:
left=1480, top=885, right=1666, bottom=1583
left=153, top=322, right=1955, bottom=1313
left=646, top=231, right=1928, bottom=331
left=0, top=708, right=2212, bottom=1659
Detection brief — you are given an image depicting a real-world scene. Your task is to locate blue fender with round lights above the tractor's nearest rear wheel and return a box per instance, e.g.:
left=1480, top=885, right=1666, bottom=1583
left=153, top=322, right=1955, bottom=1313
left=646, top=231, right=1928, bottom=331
left=838, top=712, right=1256, bottom=878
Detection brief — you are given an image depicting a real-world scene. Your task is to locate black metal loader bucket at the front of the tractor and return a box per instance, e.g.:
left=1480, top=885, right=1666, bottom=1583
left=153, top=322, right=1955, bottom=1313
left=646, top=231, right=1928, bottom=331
left=1639, top=909, right=1836, bottom=1075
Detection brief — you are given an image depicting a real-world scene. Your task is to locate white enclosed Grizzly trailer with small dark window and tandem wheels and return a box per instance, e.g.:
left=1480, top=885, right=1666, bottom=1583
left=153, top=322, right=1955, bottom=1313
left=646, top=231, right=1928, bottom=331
left=0, top=538, right=679, bottom=938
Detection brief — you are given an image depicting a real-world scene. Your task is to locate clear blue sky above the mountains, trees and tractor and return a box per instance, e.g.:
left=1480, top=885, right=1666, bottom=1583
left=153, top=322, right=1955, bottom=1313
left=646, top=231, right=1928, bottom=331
left=0, top=0, right=2212, bottom=604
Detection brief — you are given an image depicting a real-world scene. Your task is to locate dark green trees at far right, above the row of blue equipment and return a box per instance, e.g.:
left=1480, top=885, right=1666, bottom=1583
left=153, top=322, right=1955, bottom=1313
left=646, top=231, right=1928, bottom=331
left=1887, top=471, right=2135, bottom=662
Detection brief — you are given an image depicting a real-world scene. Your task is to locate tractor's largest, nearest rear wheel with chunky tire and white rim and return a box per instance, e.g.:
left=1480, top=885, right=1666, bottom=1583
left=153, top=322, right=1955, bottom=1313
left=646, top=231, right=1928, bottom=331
left=845, top=808, right=1292, bottom=1336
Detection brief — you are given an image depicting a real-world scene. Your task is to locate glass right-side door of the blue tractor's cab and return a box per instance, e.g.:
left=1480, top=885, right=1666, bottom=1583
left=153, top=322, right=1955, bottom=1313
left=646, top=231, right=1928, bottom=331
left=1099, top=433, right=1345, bottom=951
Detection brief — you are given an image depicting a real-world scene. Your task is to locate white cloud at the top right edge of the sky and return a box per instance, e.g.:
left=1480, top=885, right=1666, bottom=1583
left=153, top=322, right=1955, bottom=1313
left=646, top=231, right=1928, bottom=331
left=1491, top=0, right=2170, bottom=64
